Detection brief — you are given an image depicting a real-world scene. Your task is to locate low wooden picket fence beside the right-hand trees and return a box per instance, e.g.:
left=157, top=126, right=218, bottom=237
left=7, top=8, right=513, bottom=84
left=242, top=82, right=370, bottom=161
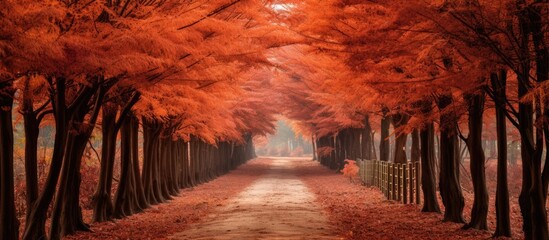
left=356, top=159, right=421, bottom=204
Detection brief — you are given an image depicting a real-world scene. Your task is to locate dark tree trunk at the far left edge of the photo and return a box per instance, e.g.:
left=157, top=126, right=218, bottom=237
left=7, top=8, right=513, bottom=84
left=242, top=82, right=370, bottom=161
left=0, top=81, right=19, bottom=240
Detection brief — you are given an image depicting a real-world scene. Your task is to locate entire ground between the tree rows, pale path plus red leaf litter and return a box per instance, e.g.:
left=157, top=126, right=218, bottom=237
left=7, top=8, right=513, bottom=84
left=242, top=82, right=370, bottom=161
left=68, top=158, right=522, bottom=239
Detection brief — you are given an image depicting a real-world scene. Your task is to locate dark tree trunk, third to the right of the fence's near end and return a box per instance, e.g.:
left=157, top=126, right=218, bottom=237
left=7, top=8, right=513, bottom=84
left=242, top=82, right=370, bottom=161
left=464, top=92, right=489, bottom=230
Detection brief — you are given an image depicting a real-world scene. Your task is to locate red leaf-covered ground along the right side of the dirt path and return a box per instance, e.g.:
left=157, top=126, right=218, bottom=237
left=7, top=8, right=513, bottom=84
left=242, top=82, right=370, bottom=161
left=294, top=158, right=522, bottom=240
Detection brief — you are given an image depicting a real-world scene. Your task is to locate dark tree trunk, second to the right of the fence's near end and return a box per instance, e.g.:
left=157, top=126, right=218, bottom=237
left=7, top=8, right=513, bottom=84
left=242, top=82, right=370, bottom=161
left=437, top=94, right=465, bottom=223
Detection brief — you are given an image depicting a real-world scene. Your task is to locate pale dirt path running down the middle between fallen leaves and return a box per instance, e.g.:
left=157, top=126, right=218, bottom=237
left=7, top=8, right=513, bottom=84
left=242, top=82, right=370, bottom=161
left=171, top=158, right=339, bottom=239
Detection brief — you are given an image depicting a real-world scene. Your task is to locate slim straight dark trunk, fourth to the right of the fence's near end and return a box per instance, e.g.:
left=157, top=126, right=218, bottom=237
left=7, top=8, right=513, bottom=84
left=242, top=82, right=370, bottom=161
left=490, top=70, right=511, bottom=237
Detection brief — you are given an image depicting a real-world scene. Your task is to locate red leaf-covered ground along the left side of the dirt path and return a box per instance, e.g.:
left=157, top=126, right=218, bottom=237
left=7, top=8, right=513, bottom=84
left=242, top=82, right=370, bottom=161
left=66, top=158, right=272, bottom=240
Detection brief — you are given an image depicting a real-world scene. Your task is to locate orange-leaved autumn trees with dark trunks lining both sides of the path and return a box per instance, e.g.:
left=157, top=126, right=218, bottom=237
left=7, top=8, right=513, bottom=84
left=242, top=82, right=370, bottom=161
left=0, top=0, right=549, bottom=239
